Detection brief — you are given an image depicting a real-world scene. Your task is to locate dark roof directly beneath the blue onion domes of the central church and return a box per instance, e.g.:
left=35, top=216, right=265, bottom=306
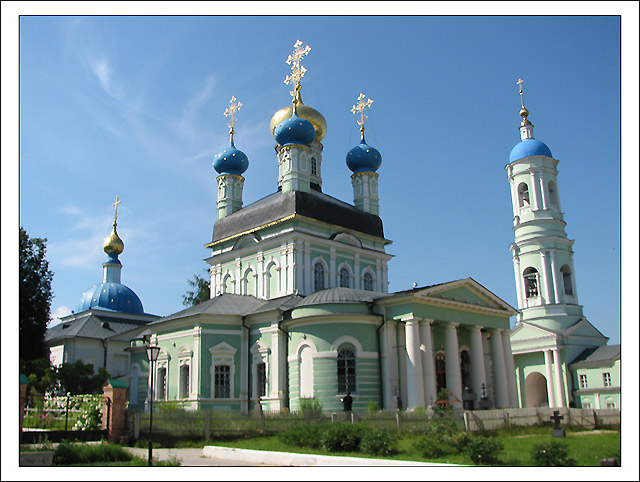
left=212, top=186, right=384, bottom=242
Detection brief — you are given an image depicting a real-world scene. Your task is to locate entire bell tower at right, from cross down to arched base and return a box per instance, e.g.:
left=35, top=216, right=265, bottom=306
left=505, top=80, right=619, bottom=408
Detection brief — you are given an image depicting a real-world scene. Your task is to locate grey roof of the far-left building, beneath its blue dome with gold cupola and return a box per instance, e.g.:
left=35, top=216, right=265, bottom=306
left=45, top=312, right=148, bottom=342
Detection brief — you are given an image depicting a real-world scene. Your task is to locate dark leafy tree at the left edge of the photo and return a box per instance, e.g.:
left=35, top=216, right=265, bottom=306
left=18, top=227, right=53, bottom=361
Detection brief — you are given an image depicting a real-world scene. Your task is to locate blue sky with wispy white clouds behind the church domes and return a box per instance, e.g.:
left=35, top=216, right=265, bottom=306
left=2, top=2, right=637, bottom=352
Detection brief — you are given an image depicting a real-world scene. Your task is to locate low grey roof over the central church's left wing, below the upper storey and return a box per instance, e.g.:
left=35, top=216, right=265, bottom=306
left=154, top=293, right=302, bottom=323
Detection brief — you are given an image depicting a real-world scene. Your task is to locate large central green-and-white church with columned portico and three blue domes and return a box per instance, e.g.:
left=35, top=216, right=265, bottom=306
left=129, top=41, right=518, bottom=412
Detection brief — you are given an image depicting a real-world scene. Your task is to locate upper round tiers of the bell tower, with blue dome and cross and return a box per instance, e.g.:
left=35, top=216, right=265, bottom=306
left=505, top=79, right=583, bottom=330
